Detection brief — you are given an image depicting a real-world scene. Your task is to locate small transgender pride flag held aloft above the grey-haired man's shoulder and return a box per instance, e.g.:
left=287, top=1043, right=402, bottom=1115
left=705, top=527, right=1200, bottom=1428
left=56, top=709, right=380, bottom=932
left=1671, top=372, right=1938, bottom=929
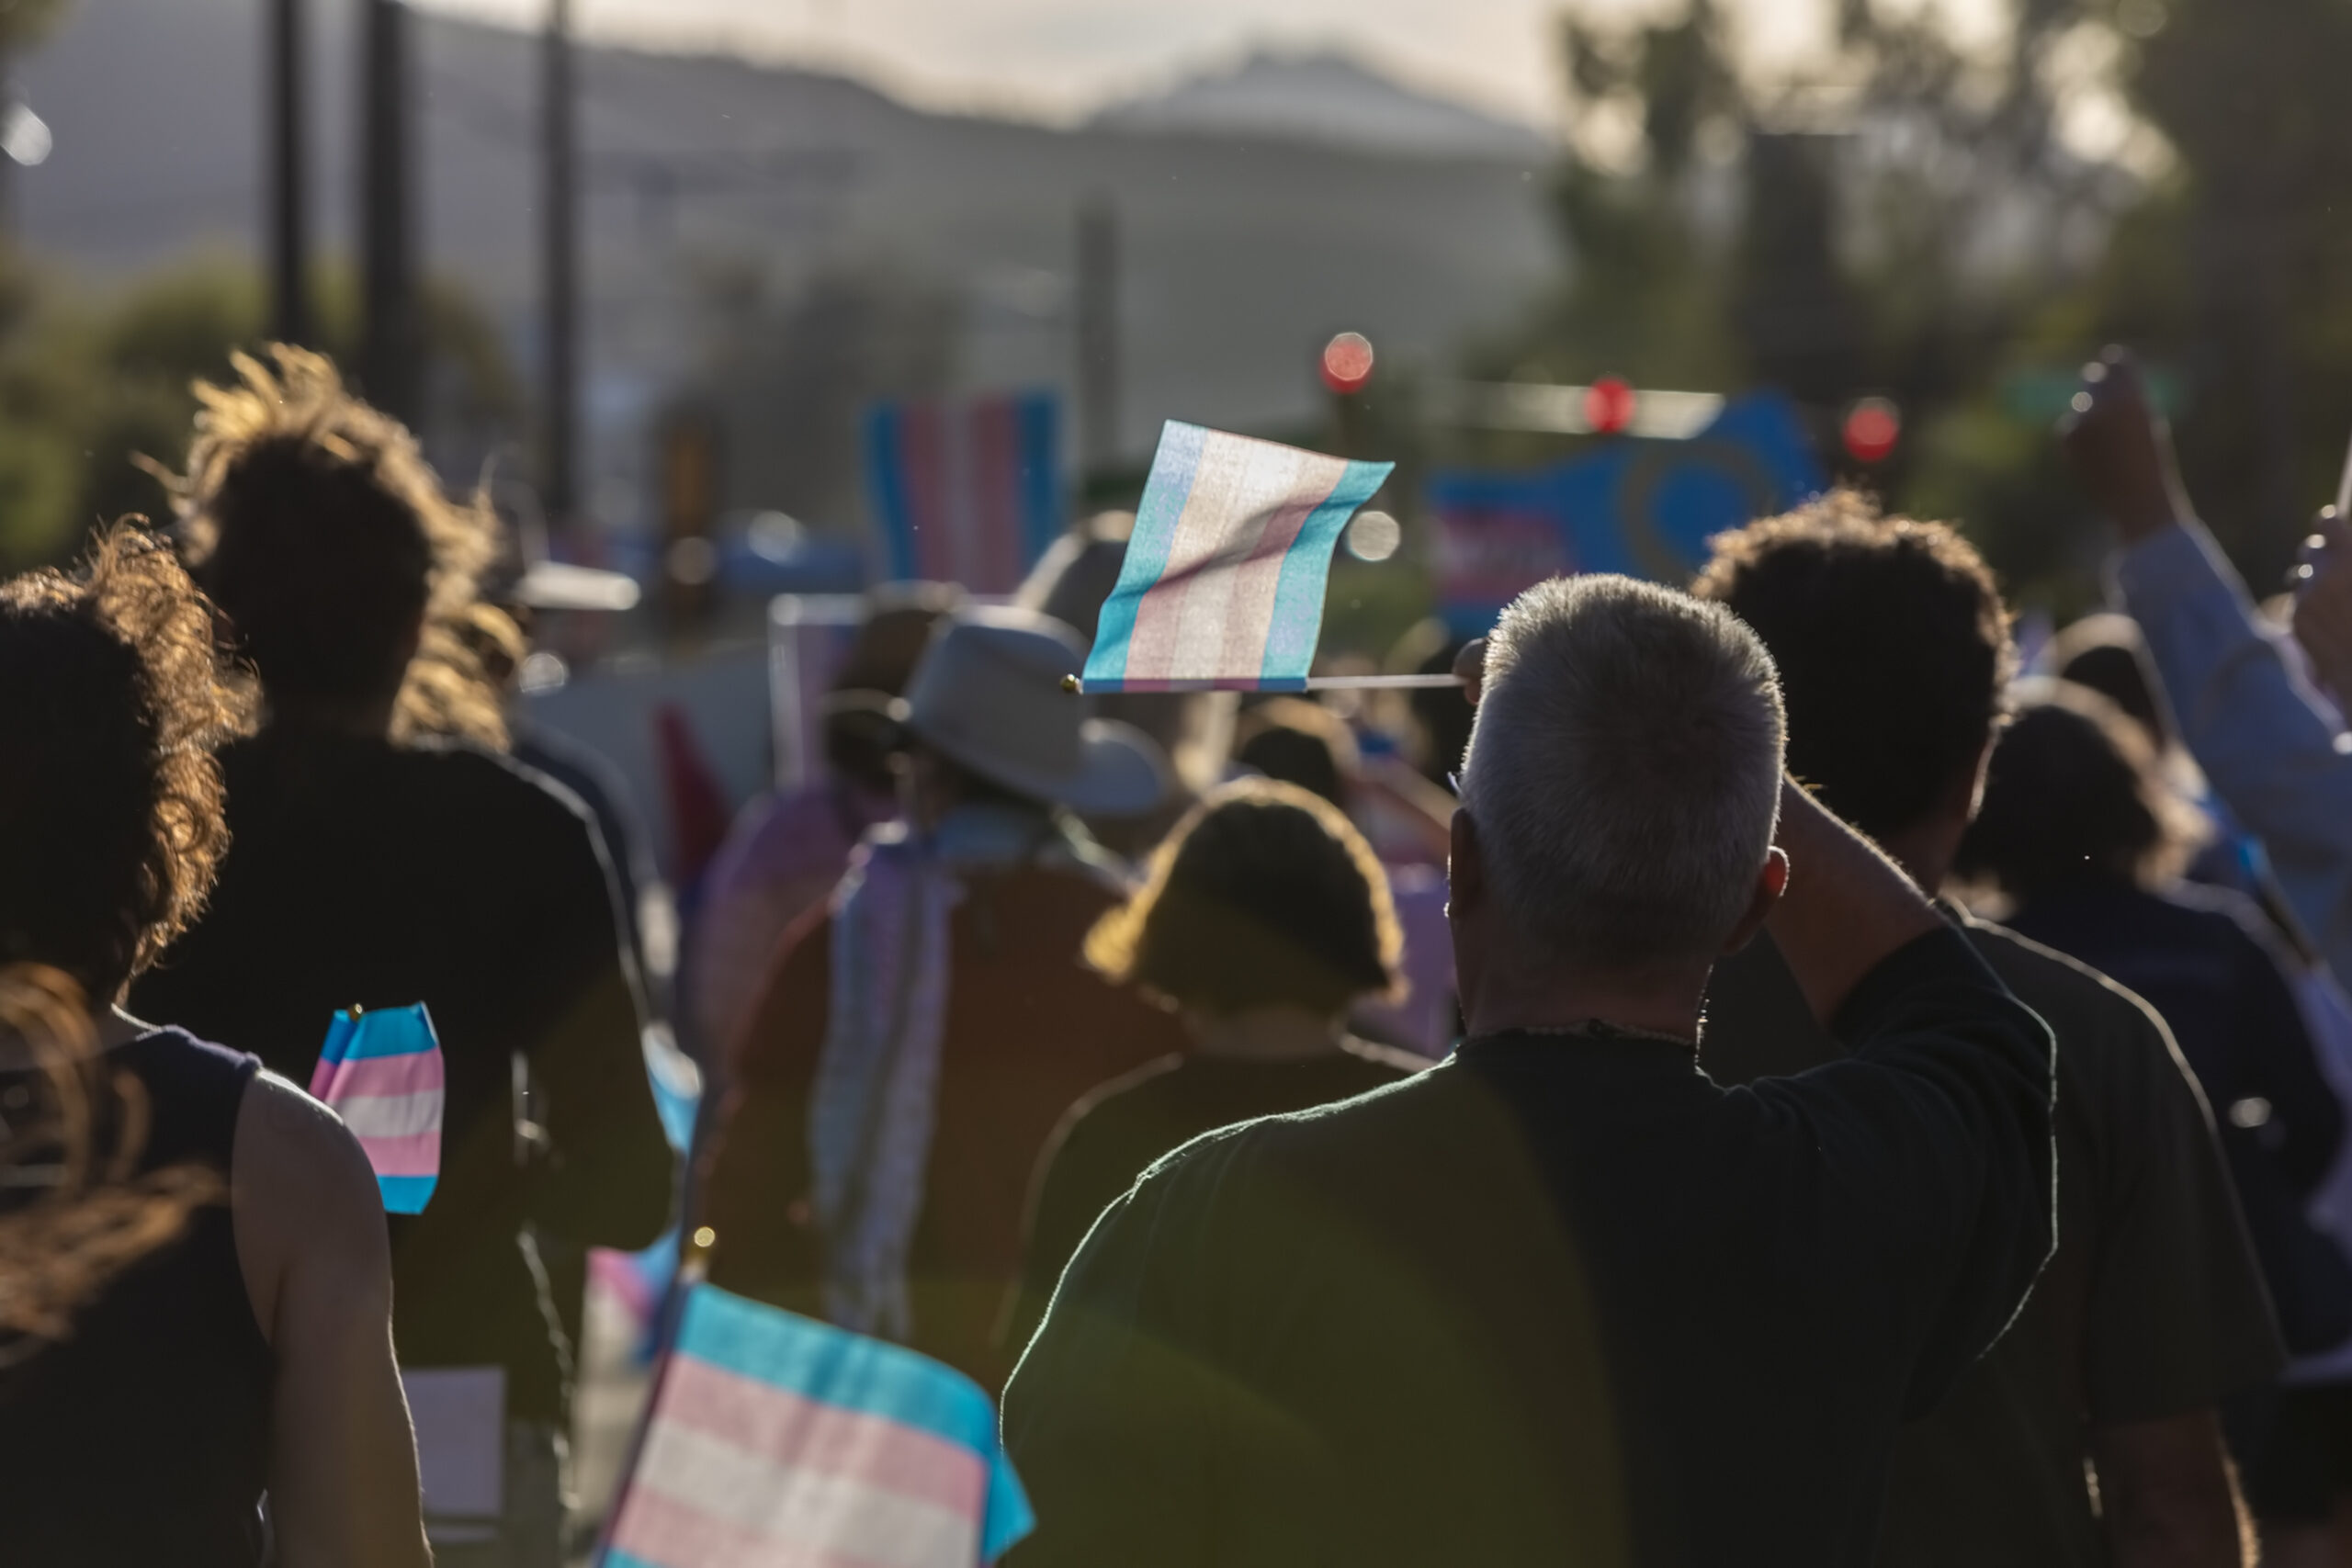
left=1082, top=419, right=1395, bottom=691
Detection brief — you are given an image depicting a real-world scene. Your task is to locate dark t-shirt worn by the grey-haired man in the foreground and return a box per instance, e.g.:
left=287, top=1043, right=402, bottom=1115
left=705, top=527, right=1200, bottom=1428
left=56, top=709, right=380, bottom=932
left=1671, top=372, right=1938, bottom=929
left=1004, top=931, right=2051, bottom=1568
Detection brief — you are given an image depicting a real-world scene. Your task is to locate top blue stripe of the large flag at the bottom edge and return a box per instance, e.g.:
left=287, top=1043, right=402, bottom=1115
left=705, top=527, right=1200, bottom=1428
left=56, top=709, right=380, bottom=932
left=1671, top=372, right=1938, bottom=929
left=675, top=1286, right=997, bottom=1458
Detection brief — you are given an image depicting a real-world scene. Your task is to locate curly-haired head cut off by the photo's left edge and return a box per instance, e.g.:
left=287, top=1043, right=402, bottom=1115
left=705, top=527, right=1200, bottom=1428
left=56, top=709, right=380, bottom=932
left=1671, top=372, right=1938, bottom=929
left=0, top=526, right=243, bottom=1004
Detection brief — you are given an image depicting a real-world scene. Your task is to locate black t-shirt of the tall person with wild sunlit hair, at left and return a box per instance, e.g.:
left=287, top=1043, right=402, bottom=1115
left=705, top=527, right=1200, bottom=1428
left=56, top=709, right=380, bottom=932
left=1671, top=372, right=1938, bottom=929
left=131, top=731, right=673, bottom=1417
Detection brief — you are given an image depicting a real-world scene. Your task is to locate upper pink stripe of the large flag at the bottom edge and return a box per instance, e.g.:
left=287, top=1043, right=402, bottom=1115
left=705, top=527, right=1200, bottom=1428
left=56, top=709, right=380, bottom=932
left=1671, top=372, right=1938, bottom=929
left=656, top=1354, right=988, bottom=1518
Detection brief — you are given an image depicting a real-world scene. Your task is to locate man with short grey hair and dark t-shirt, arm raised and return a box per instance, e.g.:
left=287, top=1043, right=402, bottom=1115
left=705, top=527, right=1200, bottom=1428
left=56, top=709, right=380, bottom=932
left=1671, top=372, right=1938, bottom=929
left=1004, top=576, right=2053, bottom=1568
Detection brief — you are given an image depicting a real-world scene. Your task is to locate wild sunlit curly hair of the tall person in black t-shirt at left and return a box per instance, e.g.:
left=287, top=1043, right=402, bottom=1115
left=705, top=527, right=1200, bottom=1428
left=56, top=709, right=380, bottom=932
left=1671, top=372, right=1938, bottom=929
left=167, top=344, right=505, bottom=748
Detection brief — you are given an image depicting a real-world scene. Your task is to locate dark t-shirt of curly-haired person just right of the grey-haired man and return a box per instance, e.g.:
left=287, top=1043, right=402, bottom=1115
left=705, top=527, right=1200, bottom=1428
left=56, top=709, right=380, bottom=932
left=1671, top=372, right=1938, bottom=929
left=1701, top=921, right=2281, bottom=1568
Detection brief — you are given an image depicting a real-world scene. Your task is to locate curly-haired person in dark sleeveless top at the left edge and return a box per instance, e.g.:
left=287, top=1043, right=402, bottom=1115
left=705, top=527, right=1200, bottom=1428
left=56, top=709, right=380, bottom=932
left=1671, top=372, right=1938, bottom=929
left=0, top=526, right=428, bottom=1568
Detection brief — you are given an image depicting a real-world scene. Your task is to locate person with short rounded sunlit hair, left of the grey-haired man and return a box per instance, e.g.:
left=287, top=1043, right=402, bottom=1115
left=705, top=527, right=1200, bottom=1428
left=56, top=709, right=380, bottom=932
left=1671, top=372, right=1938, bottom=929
left=1009, top=778, right=1428, bottom=1347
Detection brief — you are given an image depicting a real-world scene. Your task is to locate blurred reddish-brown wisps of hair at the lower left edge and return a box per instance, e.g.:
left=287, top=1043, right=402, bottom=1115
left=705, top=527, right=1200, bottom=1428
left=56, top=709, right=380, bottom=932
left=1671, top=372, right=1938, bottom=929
left=0, top=964, right=228, bottom=1368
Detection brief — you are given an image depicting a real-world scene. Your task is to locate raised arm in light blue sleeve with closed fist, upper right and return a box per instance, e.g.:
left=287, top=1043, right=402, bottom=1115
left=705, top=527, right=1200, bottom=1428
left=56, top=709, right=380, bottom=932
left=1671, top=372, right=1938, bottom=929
left=2063, top=350, right=2352, bottom=991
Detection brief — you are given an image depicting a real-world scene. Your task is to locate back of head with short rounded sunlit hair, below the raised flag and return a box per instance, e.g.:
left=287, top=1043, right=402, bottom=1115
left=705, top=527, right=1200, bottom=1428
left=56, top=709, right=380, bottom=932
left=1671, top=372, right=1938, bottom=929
left=1087, top=778, right=1404, bottom=1016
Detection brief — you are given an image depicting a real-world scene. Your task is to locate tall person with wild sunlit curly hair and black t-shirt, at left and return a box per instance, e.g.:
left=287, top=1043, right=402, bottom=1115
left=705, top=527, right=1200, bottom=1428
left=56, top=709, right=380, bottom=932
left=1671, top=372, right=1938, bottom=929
left=136, top=345, right=675, bottom=1565
